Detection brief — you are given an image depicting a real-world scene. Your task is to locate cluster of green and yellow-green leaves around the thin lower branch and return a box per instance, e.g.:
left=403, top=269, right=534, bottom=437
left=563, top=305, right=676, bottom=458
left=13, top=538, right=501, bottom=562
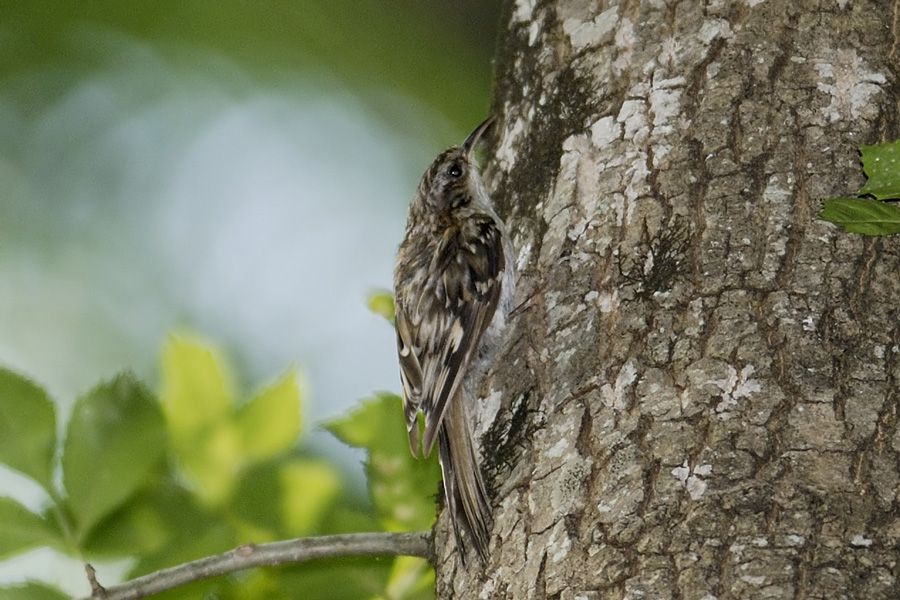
left=0, top=333, right=440, bottom=600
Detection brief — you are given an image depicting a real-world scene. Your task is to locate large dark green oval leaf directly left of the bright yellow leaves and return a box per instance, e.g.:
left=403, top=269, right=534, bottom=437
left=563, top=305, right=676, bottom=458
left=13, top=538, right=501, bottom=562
left=62, top=374, right=165, bottom=539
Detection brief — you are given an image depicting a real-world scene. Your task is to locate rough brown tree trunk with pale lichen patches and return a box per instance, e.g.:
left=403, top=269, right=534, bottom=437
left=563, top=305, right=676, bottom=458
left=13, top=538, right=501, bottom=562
left=437, top=0, right=900, bottom=600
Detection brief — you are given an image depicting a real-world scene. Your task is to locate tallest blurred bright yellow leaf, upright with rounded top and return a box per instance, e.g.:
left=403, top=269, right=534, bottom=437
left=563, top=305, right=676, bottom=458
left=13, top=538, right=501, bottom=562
left=160, top=334, right=234, bottom=443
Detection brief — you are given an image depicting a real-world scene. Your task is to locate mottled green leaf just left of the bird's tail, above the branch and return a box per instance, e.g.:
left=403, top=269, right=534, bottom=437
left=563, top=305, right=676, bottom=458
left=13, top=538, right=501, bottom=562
left=327, top=393, right=441, bottom=531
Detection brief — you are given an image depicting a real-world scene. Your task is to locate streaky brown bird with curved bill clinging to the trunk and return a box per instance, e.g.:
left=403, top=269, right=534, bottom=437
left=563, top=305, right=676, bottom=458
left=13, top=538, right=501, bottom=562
left=394, top=117, right=515, bottom=564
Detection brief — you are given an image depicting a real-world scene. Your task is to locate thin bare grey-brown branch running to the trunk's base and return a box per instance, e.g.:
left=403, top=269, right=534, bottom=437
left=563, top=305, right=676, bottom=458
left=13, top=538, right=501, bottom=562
left=76, top=531, right=432, bottom=600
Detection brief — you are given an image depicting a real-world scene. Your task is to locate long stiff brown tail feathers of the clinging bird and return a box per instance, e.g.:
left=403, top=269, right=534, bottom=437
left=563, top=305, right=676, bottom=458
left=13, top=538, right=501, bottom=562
left=438, top=397, right=491, bottom=563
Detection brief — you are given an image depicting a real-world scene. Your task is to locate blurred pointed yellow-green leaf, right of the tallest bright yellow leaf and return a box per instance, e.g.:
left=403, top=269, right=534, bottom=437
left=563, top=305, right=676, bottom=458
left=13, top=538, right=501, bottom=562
left=237, top=371, right=300, bottom=460
